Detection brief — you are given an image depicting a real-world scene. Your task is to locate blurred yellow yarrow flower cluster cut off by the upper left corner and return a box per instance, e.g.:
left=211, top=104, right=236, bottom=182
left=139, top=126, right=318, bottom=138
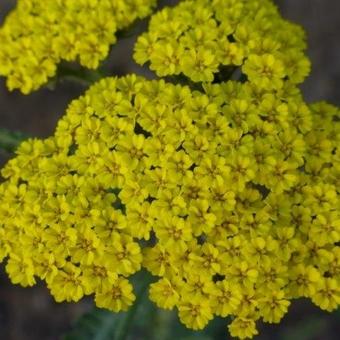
left=0, top=0, right=156, bottom=94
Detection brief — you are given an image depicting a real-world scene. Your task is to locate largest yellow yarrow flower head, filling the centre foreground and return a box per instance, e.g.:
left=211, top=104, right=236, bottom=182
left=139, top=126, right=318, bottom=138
left=0, top=76, right=340, bottom=338
